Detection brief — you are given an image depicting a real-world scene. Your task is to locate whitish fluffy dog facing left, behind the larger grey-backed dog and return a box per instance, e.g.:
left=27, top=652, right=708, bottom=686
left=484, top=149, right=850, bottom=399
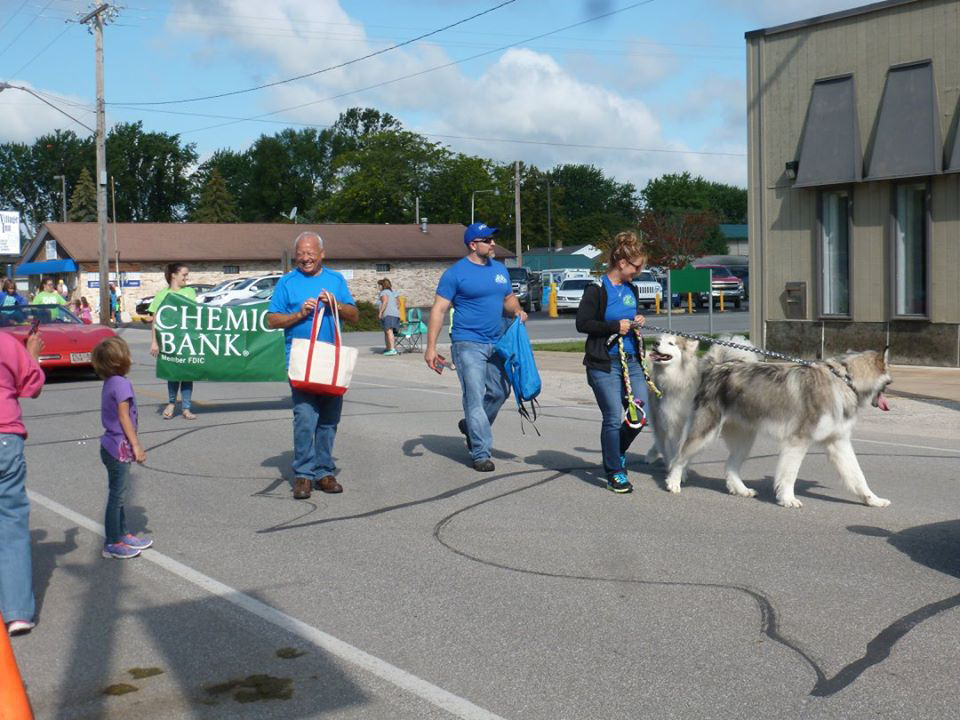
left=646, top=335, right=757, bottom=468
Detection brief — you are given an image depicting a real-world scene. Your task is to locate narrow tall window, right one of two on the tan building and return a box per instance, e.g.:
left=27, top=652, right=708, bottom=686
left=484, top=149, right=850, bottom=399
left=893, top=182, right=929, bottom=316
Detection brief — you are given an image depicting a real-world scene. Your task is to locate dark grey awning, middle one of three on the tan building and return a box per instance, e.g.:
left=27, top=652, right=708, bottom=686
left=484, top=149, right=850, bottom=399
left=866, top=60, right=943, bottom=180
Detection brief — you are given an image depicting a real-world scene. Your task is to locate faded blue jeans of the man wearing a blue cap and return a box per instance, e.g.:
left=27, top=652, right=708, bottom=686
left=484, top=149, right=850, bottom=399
left=450, top=342, right=510, bottom=462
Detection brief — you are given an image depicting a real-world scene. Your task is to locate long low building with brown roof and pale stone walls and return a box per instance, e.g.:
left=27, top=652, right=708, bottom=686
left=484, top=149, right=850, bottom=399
left=21, top=223, right=514, bottom=309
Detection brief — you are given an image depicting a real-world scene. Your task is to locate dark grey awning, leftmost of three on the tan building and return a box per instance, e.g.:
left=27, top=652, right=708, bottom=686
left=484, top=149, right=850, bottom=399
left=793, top=75, right=863, bottom=187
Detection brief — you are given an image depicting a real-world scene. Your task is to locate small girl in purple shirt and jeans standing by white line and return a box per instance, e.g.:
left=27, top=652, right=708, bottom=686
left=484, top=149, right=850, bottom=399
left=91, top=337, right=153, bottom=560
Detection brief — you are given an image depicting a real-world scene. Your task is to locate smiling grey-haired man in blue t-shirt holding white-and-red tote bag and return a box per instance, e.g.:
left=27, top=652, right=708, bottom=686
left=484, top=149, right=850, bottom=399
left=267, top=232, right=360, bottom=500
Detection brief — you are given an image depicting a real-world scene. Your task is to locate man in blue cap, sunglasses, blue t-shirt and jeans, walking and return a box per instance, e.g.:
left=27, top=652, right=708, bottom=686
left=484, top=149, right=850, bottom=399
left=423, top=223, right=527, bottom=472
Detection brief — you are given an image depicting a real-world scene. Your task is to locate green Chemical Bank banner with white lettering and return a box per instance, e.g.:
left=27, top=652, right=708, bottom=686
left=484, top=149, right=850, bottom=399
left=154, top=293, right=287, bottom=382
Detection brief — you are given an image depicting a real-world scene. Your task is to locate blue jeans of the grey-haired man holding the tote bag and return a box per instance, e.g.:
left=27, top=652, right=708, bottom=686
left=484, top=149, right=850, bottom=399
left=290, top=387, right=343, bottom=480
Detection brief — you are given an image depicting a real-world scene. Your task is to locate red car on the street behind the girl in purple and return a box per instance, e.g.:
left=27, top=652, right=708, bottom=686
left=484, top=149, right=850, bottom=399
left=0, top=305, right=116, bottom=369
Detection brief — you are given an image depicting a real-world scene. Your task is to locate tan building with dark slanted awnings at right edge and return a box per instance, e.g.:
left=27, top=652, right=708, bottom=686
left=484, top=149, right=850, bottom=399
left=746, top=0, right=960, bottom=367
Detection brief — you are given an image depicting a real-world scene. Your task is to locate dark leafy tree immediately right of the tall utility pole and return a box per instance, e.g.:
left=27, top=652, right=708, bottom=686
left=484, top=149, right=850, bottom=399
left=106, top=122, right=197, bottom=222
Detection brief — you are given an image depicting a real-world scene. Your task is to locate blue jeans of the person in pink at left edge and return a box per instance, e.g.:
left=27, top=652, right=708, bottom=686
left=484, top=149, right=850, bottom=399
left=0, top=433, right=36, bottom=632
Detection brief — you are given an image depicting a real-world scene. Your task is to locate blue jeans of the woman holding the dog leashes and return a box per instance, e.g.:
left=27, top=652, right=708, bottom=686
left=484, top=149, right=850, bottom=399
left=587, top=356, right=648, bottom=477
